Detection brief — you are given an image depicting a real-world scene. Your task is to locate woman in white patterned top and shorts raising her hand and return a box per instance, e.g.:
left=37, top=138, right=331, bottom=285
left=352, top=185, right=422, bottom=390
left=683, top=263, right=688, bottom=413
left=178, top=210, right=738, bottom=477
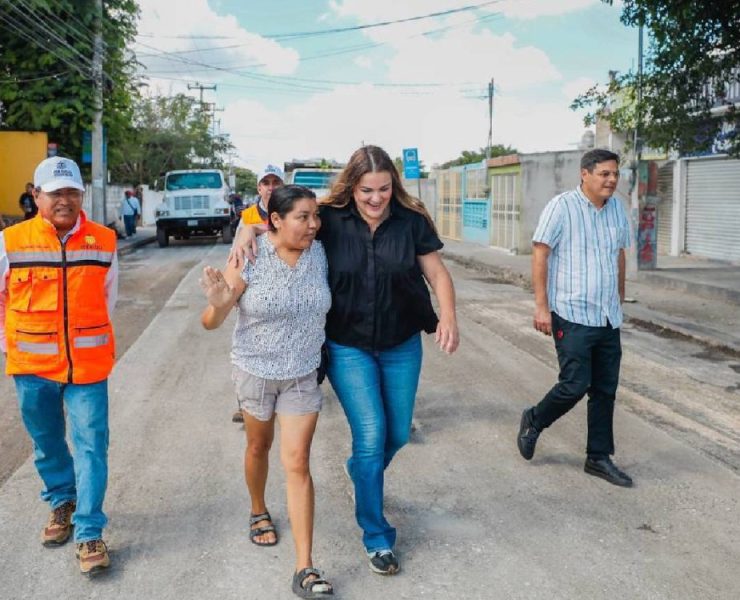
left=201, top=185, right=332, bottom=598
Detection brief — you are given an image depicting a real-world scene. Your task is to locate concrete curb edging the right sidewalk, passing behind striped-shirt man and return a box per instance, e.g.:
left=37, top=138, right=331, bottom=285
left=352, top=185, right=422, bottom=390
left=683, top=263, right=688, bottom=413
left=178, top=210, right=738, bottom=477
left=442, top=251, right=740, bottom=358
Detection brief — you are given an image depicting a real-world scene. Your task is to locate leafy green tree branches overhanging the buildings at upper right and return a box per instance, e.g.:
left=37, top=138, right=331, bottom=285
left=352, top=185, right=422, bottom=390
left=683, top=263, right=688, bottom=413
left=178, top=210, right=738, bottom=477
left=572, top=0, right=740, bottom=156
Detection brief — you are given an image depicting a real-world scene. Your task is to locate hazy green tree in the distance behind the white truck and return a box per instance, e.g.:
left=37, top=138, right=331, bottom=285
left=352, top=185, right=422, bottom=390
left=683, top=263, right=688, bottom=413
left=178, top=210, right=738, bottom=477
left=111, top=94, right=233, bottom=185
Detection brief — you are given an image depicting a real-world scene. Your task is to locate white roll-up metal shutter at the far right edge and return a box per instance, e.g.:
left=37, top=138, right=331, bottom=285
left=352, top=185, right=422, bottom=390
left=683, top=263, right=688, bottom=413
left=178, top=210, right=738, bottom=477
left=686, top=158, right=740, bottom=261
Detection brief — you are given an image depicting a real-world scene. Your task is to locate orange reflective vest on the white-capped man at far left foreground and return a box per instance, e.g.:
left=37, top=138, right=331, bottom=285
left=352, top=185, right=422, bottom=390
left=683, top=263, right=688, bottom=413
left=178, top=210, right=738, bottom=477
left=3, top=212, right=116, bottom=383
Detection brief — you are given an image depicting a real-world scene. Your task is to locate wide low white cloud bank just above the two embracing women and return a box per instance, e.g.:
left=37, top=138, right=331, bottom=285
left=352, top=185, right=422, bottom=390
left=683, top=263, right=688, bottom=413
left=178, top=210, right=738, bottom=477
left=223, top=84, right=583, bottom=169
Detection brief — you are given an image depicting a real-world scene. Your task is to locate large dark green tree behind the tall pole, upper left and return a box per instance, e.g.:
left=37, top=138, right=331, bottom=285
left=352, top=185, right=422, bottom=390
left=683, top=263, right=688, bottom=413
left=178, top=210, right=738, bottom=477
left=0, top=0, right=139, bottom=165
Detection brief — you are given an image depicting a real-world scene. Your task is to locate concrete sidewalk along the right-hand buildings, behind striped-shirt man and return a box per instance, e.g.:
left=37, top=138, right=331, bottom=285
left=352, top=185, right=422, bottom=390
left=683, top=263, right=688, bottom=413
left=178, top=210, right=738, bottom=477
left=442, top=239, right=740, bottom=356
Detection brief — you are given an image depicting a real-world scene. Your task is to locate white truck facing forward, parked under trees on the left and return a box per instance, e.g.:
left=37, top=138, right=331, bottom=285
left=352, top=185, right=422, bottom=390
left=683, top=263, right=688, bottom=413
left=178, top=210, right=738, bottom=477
left=154, top=169, right=233, bottom=248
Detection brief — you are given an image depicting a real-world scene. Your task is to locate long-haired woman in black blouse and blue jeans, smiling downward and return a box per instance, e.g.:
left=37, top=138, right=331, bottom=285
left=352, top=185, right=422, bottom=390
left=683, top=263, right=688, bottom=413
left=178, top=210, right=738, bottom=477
left=234, top=146, right=459, bottom=575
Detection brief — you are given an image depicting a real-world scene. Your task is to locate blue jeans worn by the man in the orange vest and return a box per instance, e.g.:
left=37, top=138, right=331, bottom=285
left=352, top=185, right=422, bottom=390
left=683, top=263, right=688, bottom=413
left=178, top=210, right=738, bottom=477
left=14, top=375, right=108, bottom=543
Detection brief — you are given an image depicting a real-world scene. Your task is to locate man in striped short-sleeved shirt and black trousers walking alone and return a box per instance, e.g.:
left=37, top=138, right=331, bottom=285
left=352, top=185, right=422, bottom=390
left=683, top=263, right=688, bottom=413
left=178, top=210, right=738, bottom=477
left=517, top=150, right=632, bottom=487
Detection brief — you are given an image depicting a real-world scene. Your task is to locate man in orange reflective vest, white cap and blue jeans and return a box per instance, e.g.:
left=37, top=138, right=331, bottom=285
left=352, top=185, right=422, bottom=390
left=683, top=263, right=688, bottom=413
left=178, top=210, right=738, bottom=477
left=0, top=157, right=118, bottom=574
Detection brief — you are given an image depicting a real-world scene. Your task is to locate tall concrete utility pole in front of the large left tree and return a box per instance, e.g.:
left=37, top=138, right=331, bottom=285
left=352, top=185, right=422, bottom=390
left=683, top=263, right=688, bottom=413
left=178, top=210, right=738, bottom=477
left=92, top=0, right=107, bottom=224
